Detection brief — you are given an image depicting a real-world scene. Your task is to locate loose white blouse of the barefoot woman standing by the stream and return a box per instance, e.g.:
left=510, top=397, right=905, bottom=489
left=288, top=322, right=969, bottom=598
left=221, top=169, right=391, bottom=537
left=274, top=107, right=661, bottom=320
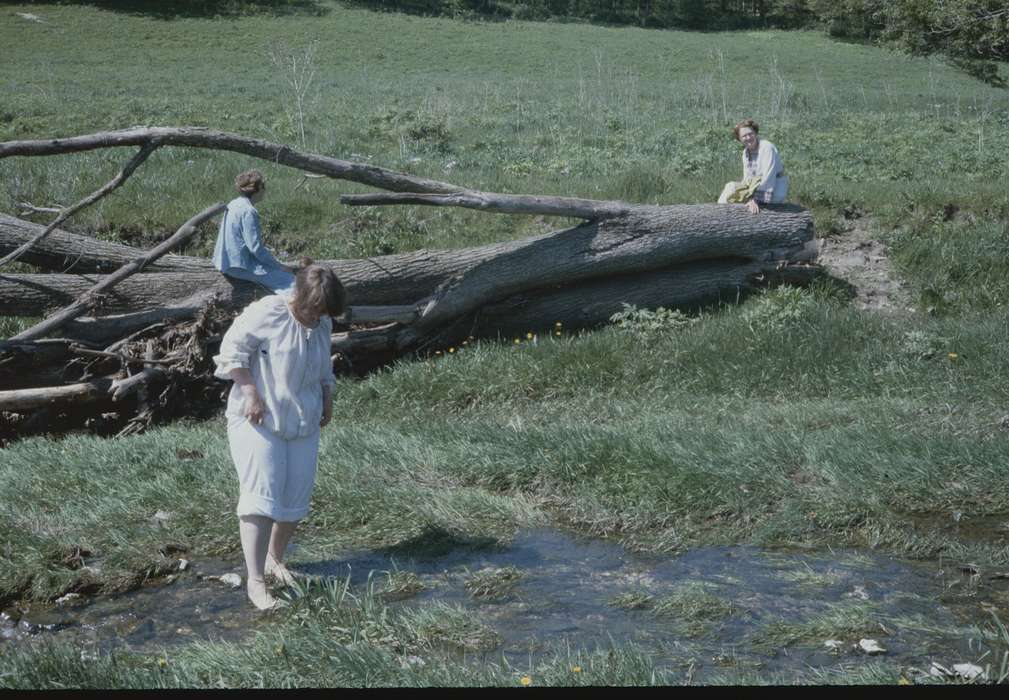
left=214, top=295, right=336, bottom=440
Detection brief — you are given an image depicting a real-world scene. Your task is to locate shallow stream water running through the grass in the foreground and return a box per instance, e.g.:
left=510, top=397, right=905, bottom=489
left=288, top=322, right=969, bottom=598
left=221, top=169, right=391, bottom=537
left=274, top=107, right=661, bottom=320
left=0, top=530, right=1009, bottom=680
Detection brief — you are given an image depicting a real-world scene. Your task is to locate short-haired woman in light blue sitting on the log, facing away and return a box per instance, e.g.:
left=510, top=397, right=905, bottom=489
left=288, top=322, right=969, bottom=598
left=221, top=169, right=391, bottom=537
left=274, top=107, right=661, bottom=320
left=214, top=170, right=295, bottom=294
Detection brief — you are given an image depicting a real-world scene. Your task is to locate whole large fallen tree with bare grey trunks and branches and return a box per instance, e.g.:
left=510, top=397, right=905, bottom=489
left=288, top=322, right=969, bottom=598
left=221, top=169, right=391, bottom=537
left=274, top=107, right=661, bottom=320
left=0, top=127, right=819, bottom=438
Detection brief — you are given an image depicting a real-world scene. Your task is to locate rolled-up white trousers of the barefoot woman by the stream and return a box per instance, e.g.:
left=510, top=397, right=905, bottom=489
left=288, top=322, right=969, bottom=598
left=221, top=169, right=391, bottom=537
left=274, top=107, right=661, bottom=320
left=228, top=416, right=319, bottom=522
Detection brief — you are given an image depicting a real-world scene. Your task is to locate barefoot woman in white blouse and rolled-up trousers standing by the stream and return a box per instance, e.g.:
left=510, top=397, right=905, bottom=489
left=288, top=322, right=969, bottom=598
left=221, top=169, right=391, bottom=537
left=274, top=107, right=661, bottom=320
left=214, top=258, right=347, bottom=610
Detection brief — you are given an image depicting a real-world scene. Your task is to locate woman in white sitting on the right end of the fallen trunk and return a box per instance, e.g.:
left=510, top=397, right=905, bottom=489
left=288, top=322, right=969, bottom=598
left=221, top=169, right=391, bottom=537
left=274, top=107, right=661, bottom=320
left=718, top=119, right=788, bottom=214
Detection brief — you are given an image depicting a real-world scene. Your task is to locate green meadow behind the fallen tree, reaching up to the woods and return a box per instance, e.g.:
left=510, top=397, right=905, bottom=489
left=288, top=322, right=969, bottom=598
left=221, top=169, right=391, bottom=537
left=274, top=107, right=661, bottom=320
left=0, top=3, right=1009, bottom=257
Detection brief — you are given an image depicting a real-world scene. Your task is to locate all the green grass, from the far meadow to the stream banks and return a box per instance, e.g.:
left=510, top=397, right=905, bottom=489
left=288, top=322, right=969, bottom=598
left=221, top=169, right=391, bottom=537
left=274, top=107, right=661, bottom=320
left=0, top=3, right=1009, bottom=687
